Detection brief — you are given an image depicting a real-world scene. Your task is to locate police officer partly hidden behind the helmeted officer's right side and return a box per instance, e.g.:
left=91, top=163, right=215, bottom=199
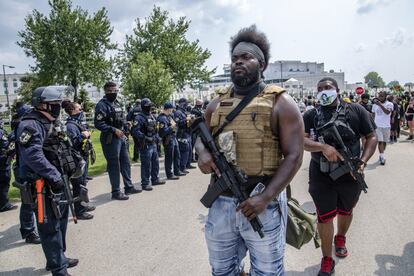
left=62, top=101, right=95, bottom=220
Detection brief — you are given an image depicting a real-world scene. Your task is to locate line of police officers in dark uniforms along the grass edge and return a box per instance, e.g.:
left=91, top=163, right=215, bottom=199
left=0, top=82, right=203, bottom=275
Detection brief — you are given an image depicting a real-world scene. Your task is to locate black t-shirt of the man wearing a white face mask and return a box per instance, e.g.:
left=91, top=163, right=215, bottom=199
left=303, top=103, right=376, bottom=159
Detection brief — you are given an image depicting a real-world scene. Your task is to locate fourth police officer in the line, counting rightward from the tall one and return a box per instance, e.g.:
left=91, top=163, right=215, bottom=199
left=174, top=98, right=195, bottom=173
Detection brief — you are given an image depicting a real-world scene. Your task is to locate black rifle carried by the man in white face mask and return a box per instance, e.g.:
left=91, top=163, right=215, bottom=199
left=317, top=122, right=368, bottom=193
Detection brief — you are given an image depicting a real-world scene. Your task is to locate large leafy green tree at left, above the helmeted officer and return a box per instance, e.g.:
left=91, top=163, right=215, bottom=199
left=17, top=0, right=116, bottom=98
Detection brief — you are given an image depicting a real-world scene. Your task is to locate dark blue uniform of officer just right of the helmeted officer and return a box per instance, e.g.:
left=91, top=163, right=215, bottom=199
left=66, top=113, right=92, bottom=218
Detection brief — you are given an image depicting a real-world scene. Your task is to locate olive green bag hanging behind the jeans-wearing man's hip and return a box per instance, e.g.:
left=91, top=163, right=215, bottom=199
left=286, top=185, right=321, bottom=249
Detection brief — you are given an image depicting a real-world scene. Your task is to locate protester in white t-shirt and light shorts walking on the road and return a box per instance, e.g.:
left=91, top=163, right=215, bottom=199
left=372, top=91, right=394, bottom=165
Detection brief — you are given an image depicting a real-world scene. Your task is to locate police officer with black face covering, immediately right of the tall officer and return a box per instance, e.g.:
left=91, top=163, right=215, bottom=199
left=131, top=98, right=165, bottom=191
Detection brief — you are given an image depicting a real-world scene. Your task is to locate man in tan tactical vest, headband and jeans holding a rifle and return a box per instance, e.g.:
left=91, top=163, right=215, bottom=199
left=193, top=26, right=303, bottom=275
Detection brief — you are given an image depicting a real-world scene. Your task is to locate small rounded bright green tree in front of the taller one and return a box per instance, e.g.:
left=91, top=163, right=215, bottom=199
left=122, top=52, right=174, bottom=106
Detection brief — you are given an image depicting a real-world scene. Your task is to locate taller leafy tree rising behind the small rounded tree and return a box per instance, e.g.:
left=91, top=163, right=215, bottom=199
left=120, top=6, right=215, bottom=90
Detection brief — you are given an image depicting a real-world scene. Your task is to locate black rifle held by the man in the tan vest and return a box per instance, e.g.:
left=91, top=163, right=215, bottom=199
left=191, top=117, right=264, bottom=238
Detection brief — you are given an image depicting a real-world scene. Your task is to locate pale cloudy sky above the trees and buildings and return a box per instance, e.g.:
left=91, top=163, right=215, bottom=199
left=0, top=0, right=414, bottom=84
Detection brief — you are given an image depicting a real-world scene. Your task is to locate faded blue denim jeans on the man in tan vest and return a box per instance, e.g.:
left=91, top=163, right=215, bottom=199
left=205, top=192, right=287, bottom=276
